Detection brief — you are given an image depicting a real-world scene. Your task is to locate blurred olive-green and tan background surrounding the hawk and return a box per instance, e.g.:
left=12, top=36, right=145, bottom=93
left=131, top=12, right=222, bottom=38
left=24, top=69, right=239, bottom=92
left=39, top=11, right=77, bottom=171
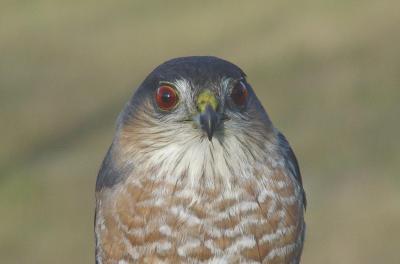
left=0, top=0, right=400, bottom=264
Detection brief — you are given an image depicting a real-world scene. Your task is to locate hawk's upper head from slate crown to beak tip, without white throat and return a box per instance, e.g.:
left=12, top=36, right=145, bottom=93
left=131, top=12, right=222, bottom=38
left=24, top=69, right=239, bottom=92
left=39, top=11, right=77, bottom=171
left=120, top=56, right=270, bottom=141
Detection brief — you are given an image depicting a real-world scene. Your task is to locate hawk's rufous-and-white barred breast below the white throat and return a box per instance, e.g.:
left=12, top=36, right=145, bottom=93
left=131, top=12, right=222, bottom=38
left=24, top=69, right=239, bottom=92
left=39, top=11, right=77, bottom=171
left=95, top=129, right=305, bottom=264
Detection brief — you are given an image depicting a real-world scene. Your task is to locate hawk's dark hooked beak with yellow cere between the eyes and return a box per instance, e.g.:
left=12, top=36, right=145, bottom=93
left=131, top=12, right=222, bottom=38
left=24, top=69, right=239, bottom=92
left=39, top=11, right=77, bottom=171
left=197, top=89, right=220, bottom=141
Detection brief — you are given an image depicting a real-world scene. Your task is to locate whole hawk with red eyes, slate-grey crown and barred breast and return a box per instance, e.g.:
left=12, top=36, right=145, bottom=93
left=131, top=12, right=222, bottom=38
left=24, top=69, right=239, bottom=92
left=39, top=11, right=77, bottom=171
left=95, top=56, right=306, bottom=264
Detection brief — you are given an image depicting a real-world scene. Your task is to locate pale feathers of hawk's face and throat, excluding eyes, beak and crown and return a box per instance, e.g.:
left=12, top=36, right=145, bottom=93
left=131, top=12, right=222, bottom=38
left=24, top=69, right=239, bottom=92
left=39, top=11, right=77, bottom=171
left=117, top=78, right=274, bottom=195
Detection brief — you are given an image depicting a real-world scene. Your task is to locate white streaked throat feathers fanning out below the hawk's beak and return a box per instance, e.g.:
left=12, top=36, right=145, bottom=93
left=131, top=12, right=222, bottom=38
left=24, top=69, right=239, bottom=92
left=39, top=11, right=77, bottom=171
left=119, top=125, right=271, bottom=191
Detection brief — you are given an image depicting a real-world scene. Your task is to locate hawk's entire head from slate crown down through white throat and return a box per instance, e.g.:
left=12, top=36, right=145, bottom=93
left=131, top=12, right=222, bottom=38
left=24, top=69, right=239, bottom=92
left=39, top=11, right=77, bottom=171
left=99, top=56, right=276, bottom=192
